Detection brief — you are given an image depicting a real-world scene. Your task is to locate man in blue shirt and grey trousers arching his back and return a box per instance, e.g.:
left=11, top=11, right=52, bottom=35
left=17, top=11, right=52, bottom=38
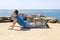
left=9, top=10, right=49, bottom=30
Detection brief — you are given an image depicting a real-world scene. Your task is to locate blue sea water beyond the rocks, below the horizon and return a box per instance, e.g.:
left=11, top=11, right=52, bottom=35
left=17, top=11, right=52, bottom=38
left=0, top=9, right=60, bottom=20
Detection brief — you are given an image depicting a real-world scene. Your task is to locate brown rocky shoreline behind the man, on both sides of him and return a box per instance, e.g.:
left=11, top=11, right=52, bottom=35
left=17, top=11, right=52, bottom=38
left=0, top=12, right=60, bottom=23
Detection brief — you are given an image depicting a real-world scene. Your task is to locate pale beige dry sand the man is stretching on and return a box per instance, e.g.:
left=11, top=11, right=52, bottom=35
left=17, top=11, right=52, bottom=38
left=0, top=23, right=60, bottom=40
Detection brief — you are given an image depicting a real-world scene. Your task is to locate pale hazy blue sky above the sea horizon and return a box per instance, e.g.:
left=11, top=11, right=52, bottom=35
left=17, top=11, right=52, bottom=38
left=0, top=0, right=60, bottom=9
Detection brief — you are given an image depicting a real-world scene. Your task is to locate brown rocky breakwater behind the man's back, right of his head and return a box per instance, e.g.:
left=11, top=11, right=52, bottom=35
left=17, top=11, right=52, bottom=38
left=11, top=13, right=60, bottom=23
